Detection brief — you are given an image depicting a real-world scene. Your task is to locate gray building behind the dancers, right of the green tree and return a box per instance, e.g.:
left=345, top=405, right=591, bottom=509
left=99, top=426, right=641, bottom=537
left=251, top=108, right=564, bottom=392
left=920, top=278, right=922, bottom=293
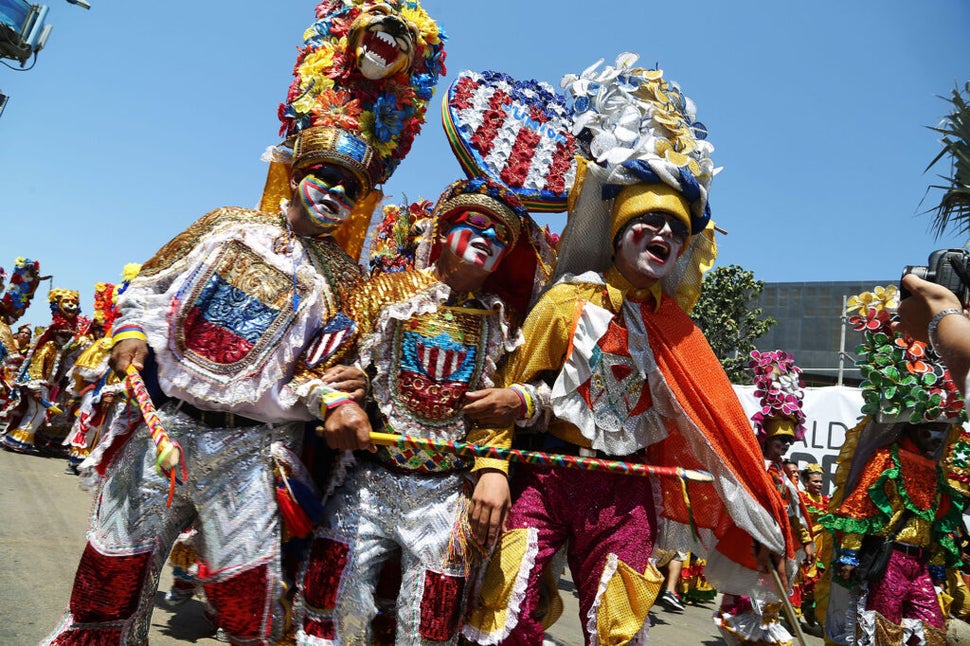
left=755, top=279, right=898, bottom=386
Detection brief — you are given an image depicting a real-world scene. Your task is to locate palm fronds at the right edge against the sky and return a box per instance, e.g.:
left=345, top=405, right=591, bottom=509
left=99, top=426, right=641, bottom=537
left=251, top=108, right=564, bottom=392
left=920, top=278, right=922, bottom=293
left=923, top=82, right=970, bottom=238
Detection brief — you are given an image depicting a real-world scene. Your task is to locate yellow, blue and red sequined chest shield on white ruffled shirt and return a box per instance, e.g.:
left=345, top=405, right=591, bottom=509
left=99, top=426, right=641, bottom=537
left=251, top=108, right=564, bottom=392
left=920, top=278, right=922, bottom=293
left=175, top=240, right=309, bottom=377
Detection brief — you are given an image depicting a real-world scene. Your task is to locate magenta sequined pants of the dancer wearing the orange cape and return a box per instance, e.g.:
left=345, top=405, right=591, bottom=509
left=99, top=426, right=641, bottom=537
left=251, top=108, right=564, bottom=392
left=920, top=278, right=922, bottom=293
left=502, top=465, right=656, bottom=644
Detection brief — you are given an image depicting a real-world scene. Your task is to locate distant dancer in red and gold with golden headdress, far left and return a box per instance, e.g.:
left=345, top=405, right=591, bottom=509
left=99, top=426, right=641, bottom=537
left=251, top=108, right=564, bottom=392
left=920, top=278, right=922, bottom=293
left=0, top=288, right=80, bottom=455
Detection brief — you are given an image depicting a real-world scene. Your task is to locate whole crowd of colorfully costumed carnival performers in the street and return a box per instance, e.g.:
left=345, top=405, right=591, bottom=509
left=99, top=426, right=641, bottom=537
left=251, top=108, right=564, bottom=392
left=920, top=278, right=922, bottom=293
left=3, top=0, right=970, bottom=646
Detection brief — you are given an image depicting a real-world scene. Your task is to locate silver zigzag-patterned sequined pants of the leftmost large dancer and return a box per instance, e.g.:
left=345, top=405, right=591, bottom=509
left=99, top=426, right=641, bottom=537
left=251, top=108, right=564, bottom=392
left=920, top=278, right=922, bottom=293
left=52, top=404, right=301, bottom=644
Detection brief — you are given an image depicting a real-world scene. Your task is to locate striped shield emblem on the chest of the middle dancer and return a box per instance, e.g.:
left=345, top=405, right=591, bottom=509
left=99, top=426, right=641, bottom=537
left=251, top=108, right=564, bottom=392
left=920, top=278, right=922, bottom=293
left=389, top=307, right=488, bottom=428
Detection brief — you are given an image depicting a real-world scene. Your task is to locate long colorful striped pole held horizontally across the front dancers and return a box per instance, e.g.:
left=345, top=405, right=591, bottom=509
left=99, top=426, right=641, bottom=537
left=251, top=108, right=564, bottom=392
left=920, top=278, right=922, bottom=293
left=370, top=432, right=714, bottom=482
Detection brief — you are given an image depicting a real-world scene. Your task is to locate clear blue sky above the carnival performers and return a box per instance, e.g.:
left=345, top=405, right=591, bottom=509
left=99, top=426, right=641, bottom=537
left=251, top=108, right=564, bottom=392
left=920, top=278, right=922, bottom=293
left=0, top=0, right=970, bottom=324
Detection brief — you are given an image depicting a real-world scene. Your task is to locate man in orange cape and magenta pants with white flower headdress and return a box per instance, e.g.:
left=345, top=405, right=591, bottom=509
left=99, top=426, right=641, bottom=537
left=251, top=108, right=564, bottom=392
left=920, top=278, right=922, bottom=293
left=463, top=54, right=794, bottom=644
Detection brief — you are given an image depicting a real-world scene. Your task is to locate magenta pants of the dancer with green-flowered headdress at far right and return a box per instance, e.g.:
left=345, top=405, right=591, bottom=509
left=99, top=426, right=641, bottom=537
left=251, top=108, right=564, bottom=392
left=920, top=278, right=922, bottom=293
left=866, top=550, right=944, bottom=630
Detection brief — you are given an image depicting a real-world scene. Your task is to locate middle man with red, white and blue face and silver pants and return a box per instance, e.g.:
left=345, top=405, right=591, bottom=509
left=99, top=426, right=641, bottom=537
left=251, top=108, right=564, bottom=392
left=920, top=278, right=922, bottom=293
left=284, top=178, right=552, bottom=644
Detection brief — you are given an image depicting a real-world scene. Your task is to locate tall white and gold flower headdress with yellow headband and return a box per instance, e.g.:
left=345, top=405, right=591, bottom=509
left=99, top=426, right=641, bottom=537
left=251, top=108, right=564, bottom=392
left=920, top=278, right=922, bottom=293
left=556, top=53, right=719, bottom=312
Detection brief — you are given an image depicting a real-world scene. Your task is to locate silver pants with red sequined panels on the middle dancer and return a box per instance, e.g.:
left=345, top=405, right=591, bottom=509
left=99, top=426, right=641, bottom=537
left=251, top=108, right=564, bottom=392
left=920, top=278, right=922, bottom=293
left=298, top=462, right=467, bottom=646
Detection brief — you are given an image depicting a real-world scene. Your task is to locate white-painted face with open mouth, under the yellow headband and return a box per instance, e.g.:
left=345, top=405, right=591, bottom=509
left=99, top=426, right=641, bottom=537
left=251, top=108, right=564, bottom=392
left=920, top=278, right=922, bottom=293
left=615, top=214, right=685, bottom=287
